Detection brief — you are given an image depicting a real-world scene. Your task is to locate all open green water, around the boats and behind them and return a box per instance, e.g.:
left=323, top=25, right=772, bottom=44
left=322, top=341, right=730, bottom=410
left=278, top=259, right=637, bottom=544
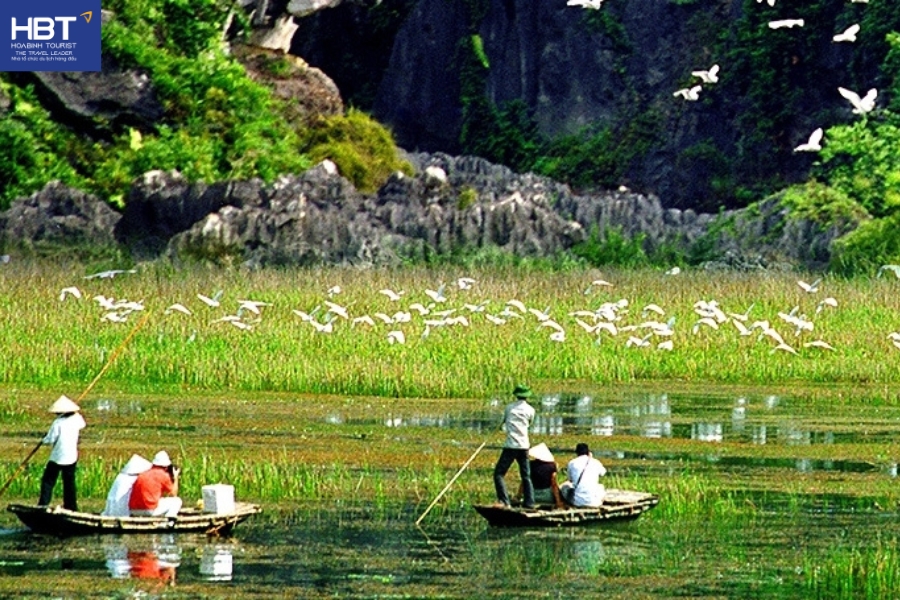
left=0, top=392, right=900, bottom=598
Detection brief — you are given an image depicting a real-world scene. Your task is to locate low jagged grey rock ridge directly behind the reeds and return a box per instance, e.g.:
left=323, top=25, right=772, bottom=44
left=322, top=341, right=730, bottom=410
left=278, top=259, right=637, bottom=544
left=0, top=154, right=855, bottom=269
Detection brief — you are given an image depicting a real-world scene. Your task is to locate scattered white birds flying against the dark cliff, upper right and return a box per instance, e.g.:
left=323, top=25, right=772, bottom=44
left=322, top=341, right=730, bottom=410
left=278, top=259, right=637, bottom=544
left=566, top=0, right=878, bottom=152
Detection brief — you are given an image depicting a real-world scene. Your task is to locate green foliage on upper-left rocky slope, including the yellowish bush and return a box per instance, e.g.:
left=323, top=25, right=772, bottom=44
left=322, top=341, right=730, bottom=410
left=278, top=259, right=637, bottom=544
left=0, top=0, right=408, bottom=209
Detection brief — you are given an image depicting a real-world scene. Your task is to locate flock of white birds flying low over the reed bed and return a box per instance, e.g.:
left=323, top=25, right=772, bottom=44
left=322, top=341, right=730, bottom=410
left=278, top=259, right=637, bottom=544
left=52, top=265, right=900, bottom=354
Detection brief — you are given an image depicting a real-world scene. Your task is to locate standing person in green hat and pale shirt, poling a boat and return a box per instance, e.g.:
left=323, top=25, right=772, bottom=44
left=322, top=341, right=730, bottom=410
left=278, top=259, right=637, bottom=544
left=494, top=385, right=534, bottom=508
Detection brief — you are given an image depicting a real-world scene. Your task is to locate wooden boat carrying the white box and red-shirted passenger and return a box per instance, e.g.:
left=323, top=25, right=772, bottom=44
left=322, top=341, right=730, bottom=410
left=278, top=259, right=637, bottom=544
left=6, top=502, right=262, bottom=536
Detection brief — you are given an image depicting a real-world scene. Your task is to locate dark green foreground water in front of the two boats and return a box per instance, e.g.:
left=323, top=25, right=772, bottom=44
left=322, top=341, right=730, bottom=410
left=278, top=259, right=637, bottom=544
left=0, top=510, right=900, bottom=598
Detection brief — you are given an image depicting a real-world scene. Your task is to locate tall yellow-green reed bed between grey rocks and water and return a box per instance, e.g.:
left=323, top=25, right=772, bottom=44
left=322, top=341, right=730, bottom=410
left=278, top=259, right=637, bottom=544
left=0, top=265, right=900, bottom=399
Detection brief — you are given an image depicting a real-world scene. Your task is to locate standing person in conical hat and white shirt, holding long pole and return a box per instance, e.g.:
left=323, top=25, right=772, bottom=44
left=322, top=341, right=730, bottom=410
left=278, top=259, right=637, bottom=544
left=38, top=394, right=86, bottom=510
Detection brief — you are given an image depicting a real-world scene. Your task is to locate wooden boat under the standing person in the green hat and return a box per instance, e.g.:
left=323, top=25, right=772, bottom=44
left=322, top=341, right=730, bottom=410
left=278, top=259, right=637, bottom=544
left=474, top=489, right=659, bottom=527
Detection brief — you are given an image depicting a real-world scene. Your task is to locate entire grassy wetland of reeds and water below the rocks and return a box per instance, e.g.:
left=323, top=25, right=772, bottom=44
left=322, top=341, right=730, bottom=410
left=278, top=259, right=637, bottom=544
left=0, top=264, right=900, bottom=598
